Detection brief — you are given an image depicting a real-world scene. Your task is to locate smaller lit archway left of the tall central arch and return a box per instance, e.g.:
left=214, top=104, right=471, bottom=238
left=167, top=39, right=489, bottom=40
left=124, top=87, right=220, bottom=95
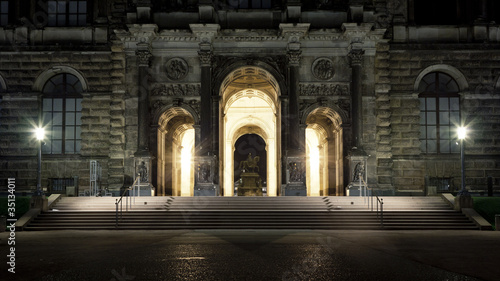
left=157, top=107, right=195, bottom=196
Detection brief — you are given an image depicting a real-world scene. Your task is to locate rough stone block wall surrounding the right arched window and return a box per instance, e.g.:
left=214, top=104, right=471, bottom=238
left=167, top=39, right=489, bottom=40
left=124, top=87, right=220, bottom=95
left=388, top=45, right=500, bottom=193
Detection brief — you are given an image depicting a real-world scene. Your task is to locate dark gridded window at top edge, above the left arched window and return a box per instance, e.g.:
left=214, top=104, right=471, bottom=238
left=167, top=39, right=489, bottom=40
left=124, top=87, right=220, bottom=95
left=47, top=0, right=87, bottom=26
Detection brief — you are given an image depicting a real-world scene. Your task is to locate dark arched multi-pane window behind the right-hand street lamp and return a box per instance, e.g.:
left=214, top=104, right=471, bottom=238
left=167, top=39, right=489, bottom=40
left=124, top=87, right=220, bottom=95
left=418, top=72, right=460, bottom=153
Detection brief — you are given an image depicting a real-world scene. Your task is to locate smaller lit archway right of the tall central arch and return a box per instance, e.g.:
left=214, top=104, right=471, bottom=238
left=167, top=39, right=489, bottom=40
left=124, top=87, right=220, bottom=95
left=306, top=107, right=344, bottom=196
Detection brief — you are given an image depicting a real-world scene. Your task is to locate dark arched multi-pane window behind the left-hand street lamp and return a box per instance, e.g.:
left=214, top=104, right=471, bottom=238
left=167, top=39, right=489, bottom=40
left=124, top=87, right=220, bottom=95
left=42, top=73, right=83, bottom=154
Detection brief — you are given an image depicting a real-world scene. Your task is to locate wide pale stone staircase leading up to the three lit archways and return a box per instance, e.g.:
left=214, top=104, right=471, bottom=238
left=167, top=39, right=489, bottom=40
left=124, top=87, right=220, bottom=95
left=24, top=196, right=478, bottom=230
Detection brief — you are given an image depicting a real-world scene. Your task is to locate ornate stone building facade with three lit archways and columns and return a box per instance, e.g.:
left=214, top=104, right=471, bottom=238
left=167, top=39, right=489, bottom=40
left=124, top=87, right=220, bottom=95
left=0, top=0, right=500, bottom=196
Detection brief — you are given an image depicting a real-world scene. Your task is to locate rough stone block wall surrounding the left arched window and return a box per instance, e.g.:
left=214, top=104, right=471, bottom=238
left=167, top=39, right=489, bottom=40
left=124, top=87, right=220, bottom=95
left=0, top=49, right=123, bottom=190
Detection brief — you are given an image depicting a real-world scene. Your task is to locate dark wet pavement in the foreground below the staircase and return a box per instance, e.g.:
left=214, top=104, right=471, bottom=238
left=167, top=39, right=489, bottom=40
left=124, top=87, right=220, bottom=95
left=0, top=230, right=500, bottom=281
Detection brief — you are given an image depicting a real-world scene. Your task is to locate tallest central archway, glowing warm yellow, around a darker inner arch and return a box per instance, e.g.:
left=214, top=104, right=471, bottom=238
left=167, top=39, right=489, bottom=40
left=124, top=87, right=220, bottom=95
left=219, top=66, right=281, bottom=196
